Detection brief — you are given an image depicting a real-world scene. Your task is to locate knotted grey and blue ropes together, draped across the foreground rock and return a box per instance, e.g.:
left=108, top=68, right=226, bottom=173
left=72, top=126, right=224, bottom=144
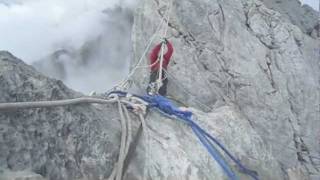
left=0, top=91, right=258, bottom=180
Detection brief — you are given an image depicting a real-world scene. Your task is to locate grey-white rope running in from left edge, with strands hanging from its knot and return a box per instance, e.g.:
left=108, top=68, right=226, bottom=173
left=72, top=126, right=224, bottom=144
left=0, top=94, right=148, bottom=180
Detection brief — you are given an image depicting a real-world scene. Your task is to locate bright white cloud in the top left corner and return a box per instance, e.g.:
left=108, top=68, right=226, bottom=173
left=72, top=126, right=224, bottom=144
left=0, top=0, right=133, bottom=63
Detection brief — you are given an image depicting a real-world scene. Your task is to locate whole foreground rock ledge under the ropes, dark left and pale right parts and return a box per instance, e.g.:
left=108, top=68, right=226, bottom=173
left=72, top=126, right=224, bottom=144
left=0, top=52, right=283, bottom=180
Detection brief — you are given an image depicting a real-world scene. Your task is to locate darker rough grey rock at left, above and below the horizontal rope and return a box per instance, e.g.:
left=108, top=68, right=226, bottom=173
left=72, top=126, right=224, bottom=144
left=0, top=51, right=120, bottom=179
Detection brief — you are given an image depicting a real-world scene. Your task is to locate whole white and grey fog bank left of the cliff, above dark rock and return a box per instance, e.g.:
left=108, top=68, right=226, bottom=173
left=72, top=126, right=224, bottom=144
left=0, top=0, right=135, bottom=93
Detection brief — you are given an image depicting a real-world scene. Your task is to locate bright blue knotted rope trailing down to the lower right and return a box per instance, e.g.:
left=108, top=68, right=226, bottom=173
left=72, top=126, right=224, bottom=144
left=107, top=91, right=259, bottom=180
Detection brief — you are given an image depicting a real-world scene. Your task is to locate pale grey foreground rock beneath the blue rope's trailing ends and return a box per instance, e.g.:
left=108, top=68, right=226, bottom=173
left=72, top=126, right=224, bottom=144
left=125, top=106, right=283, bottom=180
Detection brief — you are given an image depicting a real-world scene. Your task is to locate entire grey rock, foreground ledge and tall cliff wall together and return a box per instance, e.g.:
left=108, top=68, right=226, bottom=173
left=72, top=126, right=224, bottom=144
left=0, top=0, right=320, bottom=180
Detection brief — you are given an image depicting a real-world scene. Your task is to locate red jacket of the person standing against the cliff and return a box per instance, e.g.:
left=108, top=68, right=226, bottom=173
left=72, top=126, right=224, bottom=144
left=150, top=41, right=173, bottom=71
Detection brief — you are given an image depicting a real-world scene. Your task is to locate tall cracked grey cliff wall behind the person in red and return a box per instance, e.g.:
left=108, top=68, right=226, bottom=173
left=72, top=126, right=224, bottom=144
left=133, top=0, right=320, bottom=179
